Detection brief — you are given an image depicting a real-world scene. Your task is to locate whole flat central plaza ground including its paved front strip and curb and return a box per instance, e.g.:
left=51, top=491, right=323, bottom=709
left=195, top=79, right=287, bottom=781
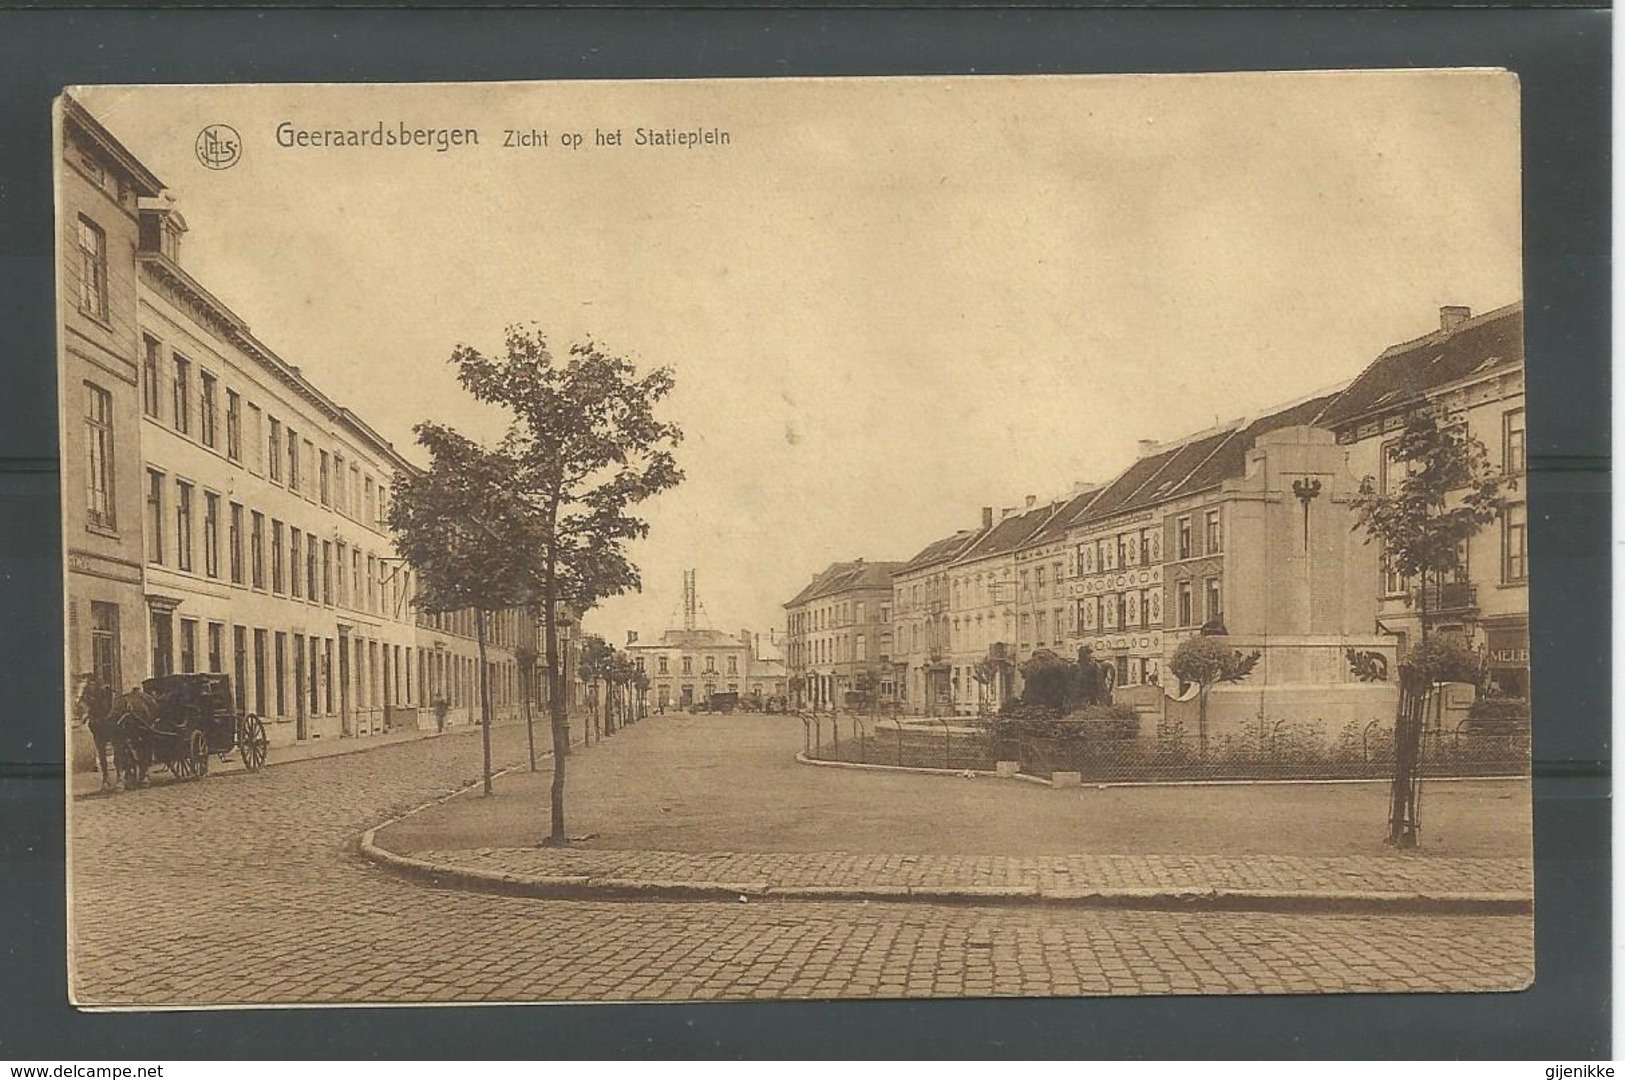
left=362, top=716, right=1534, bottom=914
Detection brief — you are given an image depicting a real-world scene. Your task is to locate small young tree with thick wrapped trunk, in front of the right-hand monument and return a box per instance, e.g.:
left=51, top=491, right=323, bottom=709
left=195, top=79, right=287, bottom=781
left=1352, top=406, right=1516, bottom=848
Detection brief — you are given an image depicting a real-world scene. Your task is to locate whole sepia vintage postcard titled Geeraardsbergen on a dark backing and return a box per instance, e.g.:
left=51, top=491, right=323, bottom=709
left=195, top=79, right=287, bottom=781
left=55, top=70, right=1534, bottom=1009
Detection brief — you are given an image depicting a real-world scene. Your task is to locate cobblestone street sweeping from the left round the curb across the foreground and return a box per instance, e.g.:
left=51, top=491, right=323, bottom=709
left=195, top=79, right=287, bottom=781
left=70, top=714, right=1534, bottom=1005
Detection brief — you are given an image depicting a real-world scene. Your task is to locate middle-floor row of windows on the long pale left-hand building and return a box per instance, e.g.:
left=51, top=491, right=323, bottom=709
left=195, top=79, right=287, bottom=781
left=146, top=469, right=413, bottom=619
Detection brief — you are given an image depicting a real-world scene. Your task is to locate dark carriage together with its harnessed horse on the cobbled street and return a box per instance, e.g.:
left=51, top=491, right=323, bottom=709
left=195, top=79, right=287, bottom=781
left=98, top=674, right=270, bottom=788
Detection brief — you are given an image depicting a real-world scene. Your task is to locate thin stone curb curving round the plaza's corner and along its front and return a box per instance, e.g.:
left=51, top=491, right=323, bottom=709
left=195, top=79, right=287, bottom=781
left=356, top=782, right=1534, bottom=916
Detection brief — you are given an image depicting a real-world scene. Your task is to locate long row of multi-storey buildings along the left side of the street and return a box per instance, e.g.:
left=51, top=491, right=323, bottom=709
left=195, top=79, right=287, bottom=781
left=60, top=99, right=552, bottom=744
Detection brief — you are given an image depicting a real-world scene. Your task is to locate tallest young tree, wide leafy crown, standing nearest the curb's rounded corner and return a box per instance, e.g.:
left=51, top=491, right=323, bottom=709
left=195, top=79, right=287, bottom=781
left=452, top=326, right=683, bottom=845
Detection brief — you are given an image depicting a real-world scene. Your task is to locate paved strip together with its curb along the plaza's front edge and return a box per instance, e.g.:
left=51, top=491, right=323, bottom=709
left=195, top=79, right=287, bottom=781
left=362, top=833, right=1532, bottom=914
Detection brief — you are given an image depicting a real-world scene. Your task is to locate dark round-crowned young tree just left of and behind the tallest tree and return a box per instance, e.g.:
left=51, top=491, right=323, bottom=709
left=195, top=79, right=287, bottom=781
left=388, top=424, right=533, bottom=794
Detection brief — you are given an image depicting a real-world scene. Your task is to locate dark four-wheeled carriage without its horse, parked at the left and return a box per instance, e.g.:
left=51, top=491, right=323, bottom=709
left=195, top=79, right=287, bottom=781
left=126, top=672, right=268, bottom=780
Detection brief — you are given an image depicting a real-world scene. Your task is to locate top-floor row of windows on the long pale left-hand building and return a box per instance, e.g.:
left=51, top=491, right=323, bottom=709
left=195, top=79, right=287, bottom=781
left=141, top=335, right=390, bottom=531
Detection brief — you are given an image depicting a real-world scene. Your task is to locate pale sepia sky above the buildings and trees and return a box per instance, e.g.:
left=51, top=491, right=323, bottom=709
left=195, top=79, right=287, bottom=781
left=75, top=71, right=1521, bottom=643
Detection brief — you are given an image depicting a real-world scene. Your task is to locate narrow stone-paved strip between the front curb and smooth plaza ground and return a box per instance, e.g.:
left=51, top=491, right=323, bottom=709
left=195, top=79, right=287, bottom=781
left=410, top=848, right=1534, bottom=896
